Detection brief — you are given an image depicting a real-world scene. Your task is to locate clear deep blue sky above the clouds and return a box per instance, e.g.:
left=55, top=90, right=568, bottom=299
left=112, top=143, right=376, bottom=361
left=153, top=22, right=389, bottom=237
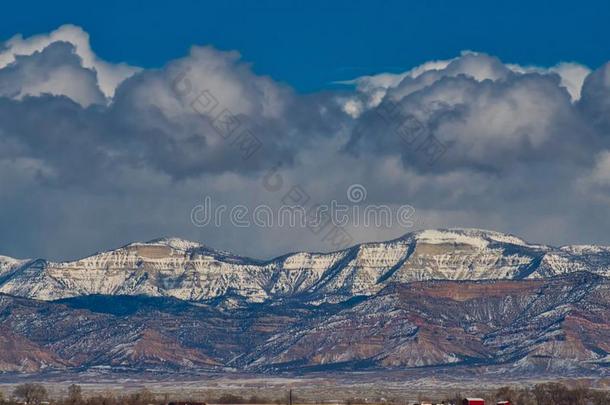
left=0, top=0, right=610, bottom=91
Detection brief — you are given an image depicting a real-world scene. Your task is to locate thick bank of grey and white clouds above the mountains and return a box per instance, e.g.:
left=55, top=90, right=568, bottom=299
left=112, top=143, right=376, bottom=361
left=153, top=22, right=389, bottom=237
left=0, top=26, right=610, bottom=258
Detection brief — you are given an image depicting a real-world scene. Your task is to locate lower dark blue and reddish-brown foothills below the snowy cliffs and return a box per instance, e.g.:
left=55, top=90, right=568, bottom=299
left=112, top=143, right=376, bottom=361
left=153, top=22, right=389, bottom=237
left=0, top=272, right=610, bottom=378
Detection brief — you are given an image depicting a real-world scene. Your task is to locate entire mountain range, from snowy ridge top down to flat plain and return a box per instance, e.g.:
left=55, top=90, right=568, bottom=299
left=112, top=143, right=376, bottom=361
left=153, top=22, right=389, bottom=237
left=0, top=229, right=610, bottom=377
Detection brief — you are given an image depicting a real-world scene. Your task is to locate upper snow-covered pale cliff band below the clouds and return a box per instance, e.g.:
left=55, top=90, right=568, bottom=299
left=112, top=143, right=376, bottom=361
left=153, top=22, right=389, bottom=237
left=0, top=229, right=610, bottom=302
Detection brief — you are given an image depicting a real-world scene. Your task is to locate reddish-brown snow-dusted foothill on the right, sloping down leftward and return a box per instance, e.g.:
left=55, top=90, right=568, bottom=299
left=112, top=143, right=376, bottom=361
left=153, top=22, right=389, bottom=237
left=237, top=273, right=610, bottom=369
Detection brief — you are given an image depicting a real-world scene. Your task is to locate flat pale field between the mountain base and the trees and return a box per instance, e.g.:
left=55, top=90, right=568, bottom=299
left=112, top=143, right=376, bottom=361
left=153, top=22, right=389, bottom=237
left=0, top=371, right=610, bottom=405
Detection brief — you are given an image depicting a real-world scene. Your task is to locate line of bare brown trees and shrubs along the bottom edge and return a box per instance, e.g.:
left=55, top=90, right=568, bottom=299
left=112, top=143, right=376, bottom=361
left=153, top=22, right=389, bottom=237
left=0, top=383, right=610, bottom=405
